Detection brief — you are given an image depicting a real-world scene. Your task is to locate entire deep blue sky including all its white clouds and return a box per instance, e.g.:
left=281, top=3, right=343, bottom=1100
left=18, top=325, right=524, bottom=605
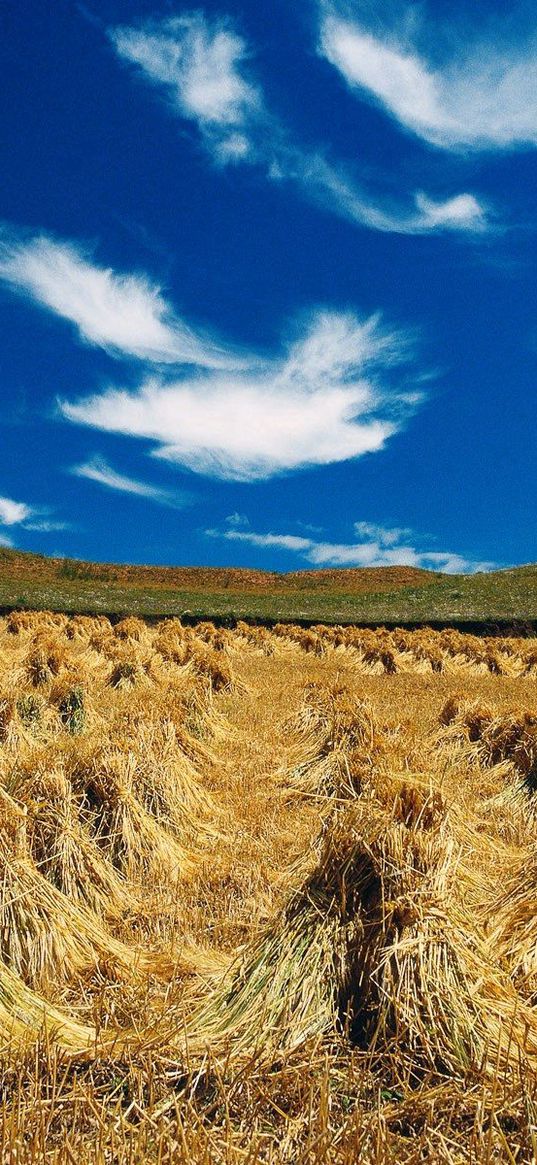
left=0, top=0, right=537, bottom=571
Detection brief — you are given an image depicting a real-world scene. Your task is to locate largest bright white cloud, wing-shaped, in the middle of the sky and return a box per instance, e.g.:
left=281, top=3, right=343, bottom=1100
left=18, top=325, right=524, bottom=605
left=59, top=311, right=421, bottom=481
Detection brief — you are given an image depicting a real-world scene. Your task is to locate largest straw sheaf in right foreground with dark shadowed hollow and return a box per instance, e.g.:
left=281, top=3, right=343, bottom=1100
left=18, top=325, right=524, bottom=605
left=188, top=799, right=537, bottom=1082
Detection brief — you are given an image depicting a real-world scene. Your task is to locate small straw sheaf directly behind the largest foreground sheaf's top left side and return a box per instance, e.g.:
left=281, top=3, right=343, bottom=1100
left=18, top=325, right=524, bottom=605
left=282, top=683, right=382, bottom=797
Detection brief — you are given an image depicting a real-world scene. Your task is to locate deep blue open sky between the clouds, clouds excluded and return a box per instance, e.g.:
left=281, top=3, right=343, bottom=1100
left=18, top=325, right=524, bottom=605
left=0, top=0, right=537, bottom=570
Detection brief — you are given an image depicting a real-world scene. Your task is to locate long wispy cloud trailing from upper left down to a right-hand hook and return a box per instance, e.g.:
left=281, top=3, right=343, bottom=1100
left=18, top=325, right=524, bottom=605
left=108, top=12, right=487, bottom=234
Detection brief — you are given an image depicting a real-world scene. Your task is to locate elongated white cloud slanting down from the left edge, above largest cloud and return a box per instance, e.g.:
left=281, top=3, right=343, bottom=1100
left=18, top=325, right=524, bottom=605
left=0, top=231, right=241, bottom=368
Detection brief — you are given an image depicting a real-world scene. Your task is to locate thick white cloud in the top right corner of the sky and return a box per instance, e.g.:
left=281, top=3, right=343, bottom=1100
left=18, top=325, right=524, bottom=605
left=319, top=2, right=537, bottom=150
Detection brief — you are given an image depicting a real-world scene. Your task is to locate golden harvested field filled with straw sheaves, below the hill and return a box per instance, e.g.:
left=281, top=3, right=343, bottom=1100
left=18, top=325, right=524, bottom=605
left=0, top=612, right=537, bottom=1165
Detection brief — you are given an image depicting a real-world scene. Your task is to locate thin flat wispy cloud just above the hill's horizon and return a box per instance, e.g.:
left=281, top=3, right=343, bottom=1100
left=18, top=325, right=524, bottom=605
left=205, top=522, right=494, bottom=574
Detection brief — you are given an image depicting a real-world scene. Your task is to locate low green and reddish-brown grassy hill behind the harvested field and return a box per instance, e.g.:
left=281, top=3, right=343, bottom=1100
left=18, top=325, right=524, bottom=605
left=0, top=549, right=537, bottom=623
